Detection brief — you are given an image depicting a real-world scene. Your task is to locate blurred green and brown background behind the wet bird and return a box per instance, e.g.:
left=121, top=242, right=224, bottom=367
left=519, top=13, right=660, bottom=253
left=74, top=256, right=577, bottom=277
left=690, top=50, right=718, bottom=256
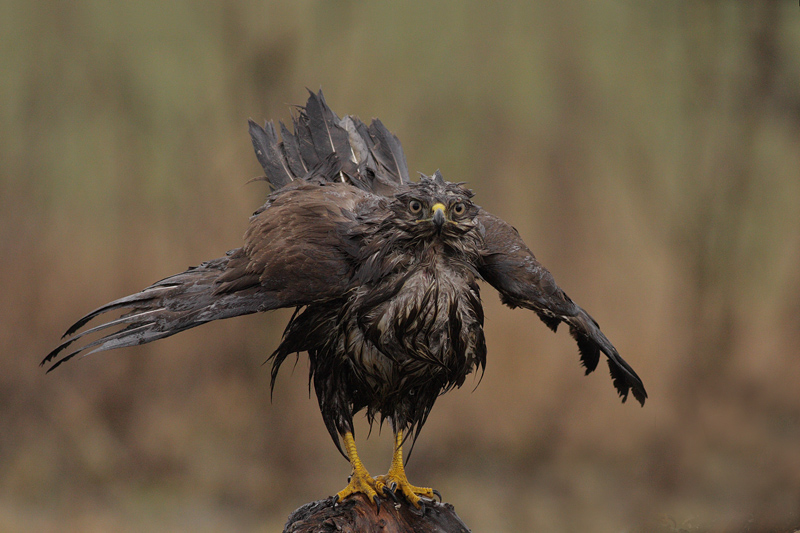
left=0, top=0, right=800, bottom=532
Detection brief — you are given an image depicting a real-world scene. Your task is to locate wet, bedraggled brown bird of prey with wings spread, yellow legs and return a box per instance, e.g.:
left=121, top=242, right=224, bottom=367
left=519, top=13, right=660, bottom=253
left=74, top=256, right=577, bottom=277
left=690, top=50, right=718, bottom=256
left=42, top=91, right=647, bottom=507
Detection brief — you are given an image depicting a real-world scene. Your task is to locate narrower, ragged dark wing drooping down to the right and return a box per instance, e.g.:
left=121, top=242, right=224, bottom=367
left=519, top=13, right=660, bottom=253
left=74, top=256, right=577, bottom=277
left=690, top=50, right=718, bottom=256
left=478, top=211, right=647, bottom=405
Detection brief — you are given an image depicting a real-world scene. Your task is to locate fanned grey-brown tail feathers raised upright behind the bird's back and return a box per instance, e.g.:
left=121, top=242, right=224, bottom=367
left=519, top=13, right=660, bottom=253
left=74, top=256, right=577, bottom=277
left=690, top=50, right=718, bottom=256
left=250, top=91, right=410, bottom=195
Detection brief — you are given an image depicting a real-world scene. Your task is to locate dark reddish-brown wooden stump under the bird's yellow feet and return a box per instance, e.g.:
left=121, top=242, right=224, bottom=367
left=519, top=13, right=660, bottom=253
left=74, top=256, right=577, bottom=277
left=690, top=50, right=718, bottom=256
left=283, top=494, right=470, bottom=533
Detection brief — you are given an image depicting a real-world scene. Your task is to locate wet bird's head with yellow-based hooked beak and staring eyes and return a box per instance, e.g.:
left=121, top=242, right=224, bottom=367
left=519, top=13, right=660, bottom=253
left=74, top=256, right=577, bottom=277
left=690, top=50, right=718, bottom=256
left=392, top=170, right=480, bottom=239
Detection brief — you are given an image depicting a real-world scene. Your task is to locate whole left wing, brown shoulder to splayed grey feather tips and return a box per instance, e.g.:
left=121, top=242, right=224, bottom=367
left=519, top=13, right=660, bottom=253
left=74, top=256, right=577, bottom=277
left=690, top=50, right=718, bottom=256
left=42, top=182, right=377, bottom=371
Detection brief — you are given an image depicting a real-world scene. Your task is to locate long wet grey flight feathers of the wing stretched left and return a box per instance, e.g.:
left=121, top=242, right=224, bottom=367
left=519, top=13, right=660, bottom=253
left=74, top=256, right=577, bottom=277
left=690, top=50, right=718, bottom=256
left=41, top=252, right=270, bottom=372
